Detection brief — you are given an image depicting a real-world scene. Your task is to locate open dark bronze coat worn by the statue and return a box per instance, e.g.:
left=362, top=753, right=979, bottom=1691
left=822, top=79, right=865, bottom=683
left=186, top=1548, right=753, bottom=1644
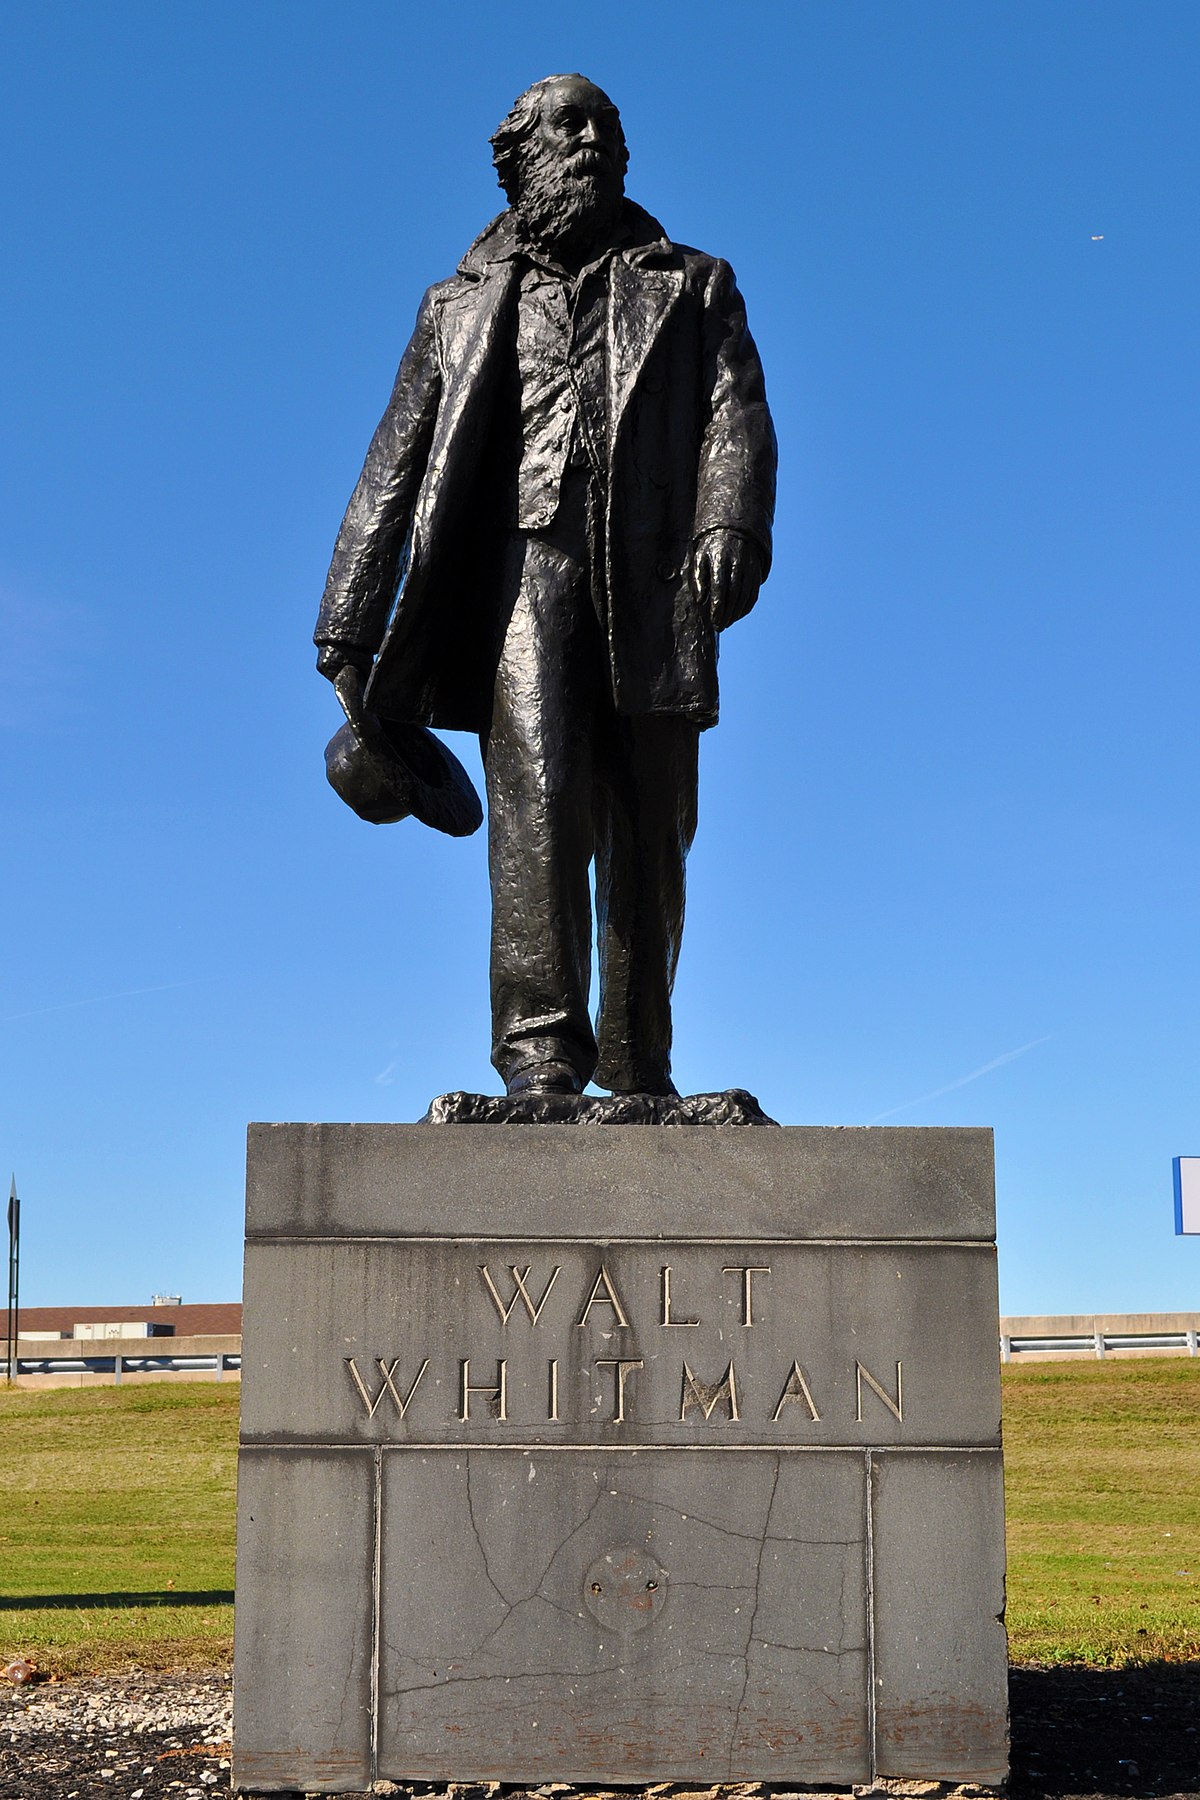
left=315, top=202, right=775, bottom=731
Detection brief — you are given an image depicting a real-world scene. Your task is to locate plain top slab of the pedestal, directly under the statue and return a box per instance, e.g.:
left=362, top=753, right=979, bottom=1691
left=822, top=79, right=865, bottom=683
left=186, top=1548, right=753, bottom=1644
left=246, top=1125, right=995, bottom=1242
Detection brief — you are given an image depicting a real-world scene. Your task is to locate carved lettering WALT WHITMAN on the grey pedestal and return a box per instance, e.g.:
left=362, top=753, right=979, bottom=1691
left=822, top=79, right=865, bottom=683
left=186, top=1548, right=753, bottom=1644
left=344, top=1251, right=905, bottom=1444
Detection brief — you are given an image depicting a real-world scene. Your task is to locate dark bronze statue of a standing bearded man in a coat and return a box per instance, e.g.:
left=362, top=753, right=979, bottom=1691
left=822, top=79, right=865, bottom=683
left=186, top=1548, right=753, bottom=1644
left=315, top=76, right=775, bottom=1096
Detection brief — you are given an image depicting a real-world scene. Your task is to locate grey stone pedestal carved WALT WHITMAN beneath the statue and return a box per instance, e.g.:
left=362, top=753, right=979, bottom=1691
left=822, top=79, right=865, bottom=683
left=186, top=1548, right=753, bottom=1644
left=234, top=1125, right=1007, bottom=1793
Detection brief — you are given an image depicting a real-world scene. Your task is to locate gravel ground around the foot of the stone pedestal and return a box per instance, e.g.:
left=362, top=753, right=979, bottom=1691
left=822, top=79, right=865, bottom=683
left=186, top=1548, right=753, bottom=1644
left=0, top=1663, right=1200, bottom=1800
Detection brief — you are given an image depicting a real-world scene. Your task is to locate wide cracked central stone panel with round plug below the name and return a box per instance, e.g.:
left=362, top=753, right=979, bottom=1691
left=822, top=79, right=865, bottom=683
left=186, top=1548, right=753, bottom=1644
left=378, top=1451, right=869, bottom=1784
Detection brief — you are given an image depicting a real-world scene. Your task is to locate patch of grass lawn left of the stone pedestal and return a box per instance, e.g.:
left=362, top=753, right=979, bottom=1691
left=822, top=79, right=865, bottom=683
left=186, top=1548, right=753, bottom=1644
left=0, top=1381, right=239, bottom=1674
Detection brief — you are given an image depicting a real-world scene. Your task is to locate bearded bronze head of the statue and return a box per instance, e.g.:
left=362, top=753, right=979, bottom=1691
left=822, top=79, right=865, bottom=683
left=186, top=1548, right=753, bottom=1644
left=491, top=76, right=630, bottom=254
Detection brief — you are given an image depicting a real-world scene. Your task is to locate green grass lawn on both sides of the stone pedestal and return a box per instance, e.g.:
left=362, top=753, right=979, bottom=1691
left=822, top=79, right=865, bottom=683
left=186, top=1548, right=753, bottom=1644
left=0, top=1357, right=1200, bottom=1674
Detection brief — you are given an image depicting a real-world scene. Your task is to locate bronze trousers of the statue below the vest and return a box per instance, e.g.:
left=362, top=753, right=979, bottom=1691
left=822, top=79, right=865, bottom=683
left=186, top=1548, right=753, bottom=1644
left=482, top=484, right=698, bottom=1093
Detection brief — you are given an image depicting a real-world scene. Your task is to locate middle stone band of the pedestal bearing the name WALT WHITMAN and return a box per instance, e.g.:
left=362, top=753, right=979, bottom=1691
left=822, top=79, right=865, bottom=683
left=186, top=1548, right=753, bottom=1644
left=241, top=1237, right=1000, bottom=1449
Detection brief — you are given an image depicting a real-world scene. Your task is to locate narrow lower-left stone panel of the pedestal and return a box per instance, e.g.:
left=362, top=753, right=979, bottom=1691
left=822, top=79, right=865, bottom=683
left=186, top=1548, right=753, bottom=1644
left=234, top=1449, right=374, bottom=1793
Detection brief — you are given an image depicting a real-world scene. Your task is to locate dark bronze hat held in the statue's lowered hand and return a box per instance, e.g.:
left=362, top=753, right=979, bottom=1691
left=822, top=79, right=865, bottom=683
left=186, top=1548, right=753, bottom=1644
left=326, top=670, right=484, bottom=837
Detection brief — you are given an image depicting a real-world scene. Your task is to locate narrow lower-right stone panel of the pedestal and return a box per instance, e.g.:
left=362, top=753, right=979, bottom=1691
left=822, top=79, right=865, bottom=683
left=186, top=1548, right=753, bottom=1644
left=873, top=1451, right=1007, bottom=1787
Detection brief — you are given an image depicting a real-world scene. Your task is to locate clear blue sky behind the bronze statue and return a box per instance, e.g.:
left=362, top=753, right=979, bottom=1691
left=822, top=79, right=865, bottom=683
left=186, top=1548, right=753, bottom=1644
left=0, top=0, right=1200, bottom=1312
